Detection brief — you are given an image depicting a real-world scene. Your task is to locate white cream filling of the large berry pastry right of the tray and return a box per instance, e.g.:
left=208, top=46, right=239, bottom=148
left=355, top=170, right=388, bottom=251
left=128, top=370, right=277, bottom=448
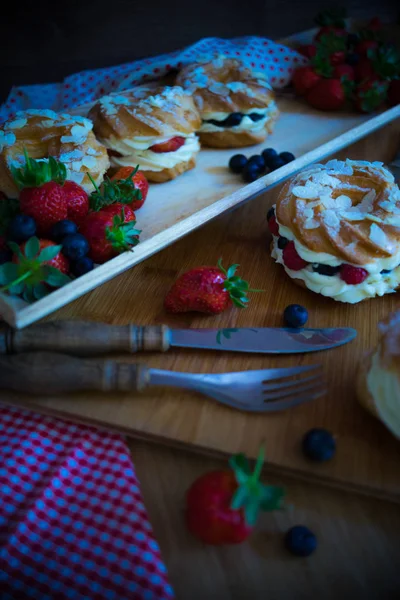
left=271, top=232, right=400, bottom=304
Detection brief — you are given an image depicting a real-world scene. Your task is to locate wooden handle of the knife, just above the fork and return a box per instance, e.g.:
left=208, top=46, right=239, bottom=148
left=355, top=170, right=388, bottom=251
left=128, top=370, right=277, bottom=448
left=0, top=321, right=169, bottom=356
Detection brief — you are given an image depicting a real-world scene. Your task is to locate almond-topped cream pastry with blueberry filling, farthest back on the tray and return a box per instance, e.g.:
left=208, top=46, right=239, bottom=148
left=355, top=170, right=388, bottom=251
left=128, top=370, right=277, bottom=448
left=177, top=56, right=279, bottom=148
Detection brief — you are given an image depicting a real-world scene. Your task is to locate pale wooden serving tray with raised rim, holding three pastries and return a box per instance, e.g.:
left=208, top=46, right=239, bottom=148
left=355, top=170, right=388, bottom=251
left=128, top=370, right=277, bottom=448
left=0, top=30, right=400, bottom=328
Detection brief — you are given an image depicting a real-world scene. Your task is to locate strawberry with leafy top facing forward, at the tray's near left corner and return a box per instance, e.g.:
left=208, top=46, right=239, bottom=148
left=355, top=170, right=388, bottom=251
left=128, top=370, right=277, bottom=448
left=0, top=237, right=70, bottom=302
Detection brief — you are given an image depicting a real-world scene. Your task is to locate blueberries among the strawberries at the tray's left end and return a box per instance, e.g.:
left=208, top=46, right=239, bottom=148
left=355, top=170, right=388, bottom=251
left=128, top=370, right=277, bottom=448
left=0, top=214, right=94, bottom=277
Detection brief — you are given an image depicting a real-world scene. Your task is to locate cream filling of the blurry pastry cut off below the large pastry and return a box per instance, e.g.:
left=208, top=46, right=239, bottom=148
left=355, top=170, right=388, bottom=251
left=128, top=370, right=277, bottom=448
left=367, top=349, right=400, bottom=439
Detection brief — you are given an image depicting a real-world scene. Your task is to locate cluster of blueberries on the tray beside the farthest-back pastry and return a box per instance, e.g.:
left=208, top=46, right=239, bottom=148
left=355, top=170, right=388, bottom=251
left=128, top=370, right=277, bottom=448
left=229, top=148, right=295, bottom=183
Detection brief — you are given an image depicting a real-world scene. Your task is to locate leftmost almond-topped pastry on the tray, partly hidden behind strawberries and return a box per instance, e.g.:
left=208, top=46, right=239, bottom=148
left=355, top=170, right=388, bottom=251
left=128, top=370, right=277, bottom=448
left=0, top=109, right=110, bottom=198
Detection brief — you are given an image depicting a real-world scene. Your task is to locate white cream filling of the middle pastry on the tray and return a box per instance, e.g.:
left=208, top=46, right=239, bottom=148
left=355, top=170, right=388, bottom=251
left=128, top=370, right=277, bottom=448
left=110, top=133, right=200, bottom=171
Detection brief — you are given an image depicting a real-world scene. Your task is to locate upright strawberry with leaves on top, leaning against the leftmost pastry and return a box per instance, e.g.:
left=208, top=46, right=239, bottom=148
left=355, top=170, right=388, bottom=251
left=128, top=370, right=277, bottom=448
left=11, top=151, right=67, bottom=234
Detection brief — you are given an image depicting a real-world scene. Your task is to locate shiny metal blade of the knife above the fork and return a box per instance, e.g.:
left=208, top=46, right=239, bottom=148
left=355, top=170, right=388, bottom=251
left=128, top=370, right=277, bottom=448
left=168, top=327, right=357, bottom=354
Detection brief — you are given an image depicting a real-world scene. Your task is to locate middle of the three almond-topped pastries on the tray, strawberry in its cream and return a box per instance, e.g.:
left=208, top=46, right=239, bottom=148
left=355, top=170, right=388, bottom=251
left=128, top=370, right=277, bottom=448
left=89, top=86, right=201, bottom=182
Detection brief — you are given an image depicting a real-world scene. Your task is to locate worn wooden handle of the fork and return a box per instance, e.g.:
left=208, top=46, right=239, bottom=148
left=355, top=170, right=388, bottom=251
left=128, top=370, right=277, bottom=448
left=0, top=352, right=149, bottom=396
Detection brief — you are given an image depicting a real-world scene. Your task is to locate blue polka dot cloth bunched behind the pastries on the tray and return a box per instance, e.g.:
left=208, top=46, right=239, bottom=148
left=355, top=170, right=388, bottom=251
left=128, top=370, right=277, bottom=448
left=0, top=36, right=308, bottom=121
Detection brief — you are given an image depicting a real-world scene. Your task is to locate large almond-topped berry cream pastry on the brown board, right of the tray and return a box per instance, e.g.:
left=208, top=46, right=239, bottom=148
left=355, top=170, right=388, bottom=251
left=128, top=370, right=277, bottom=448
left=268, top=160, right=400, bottom=304
